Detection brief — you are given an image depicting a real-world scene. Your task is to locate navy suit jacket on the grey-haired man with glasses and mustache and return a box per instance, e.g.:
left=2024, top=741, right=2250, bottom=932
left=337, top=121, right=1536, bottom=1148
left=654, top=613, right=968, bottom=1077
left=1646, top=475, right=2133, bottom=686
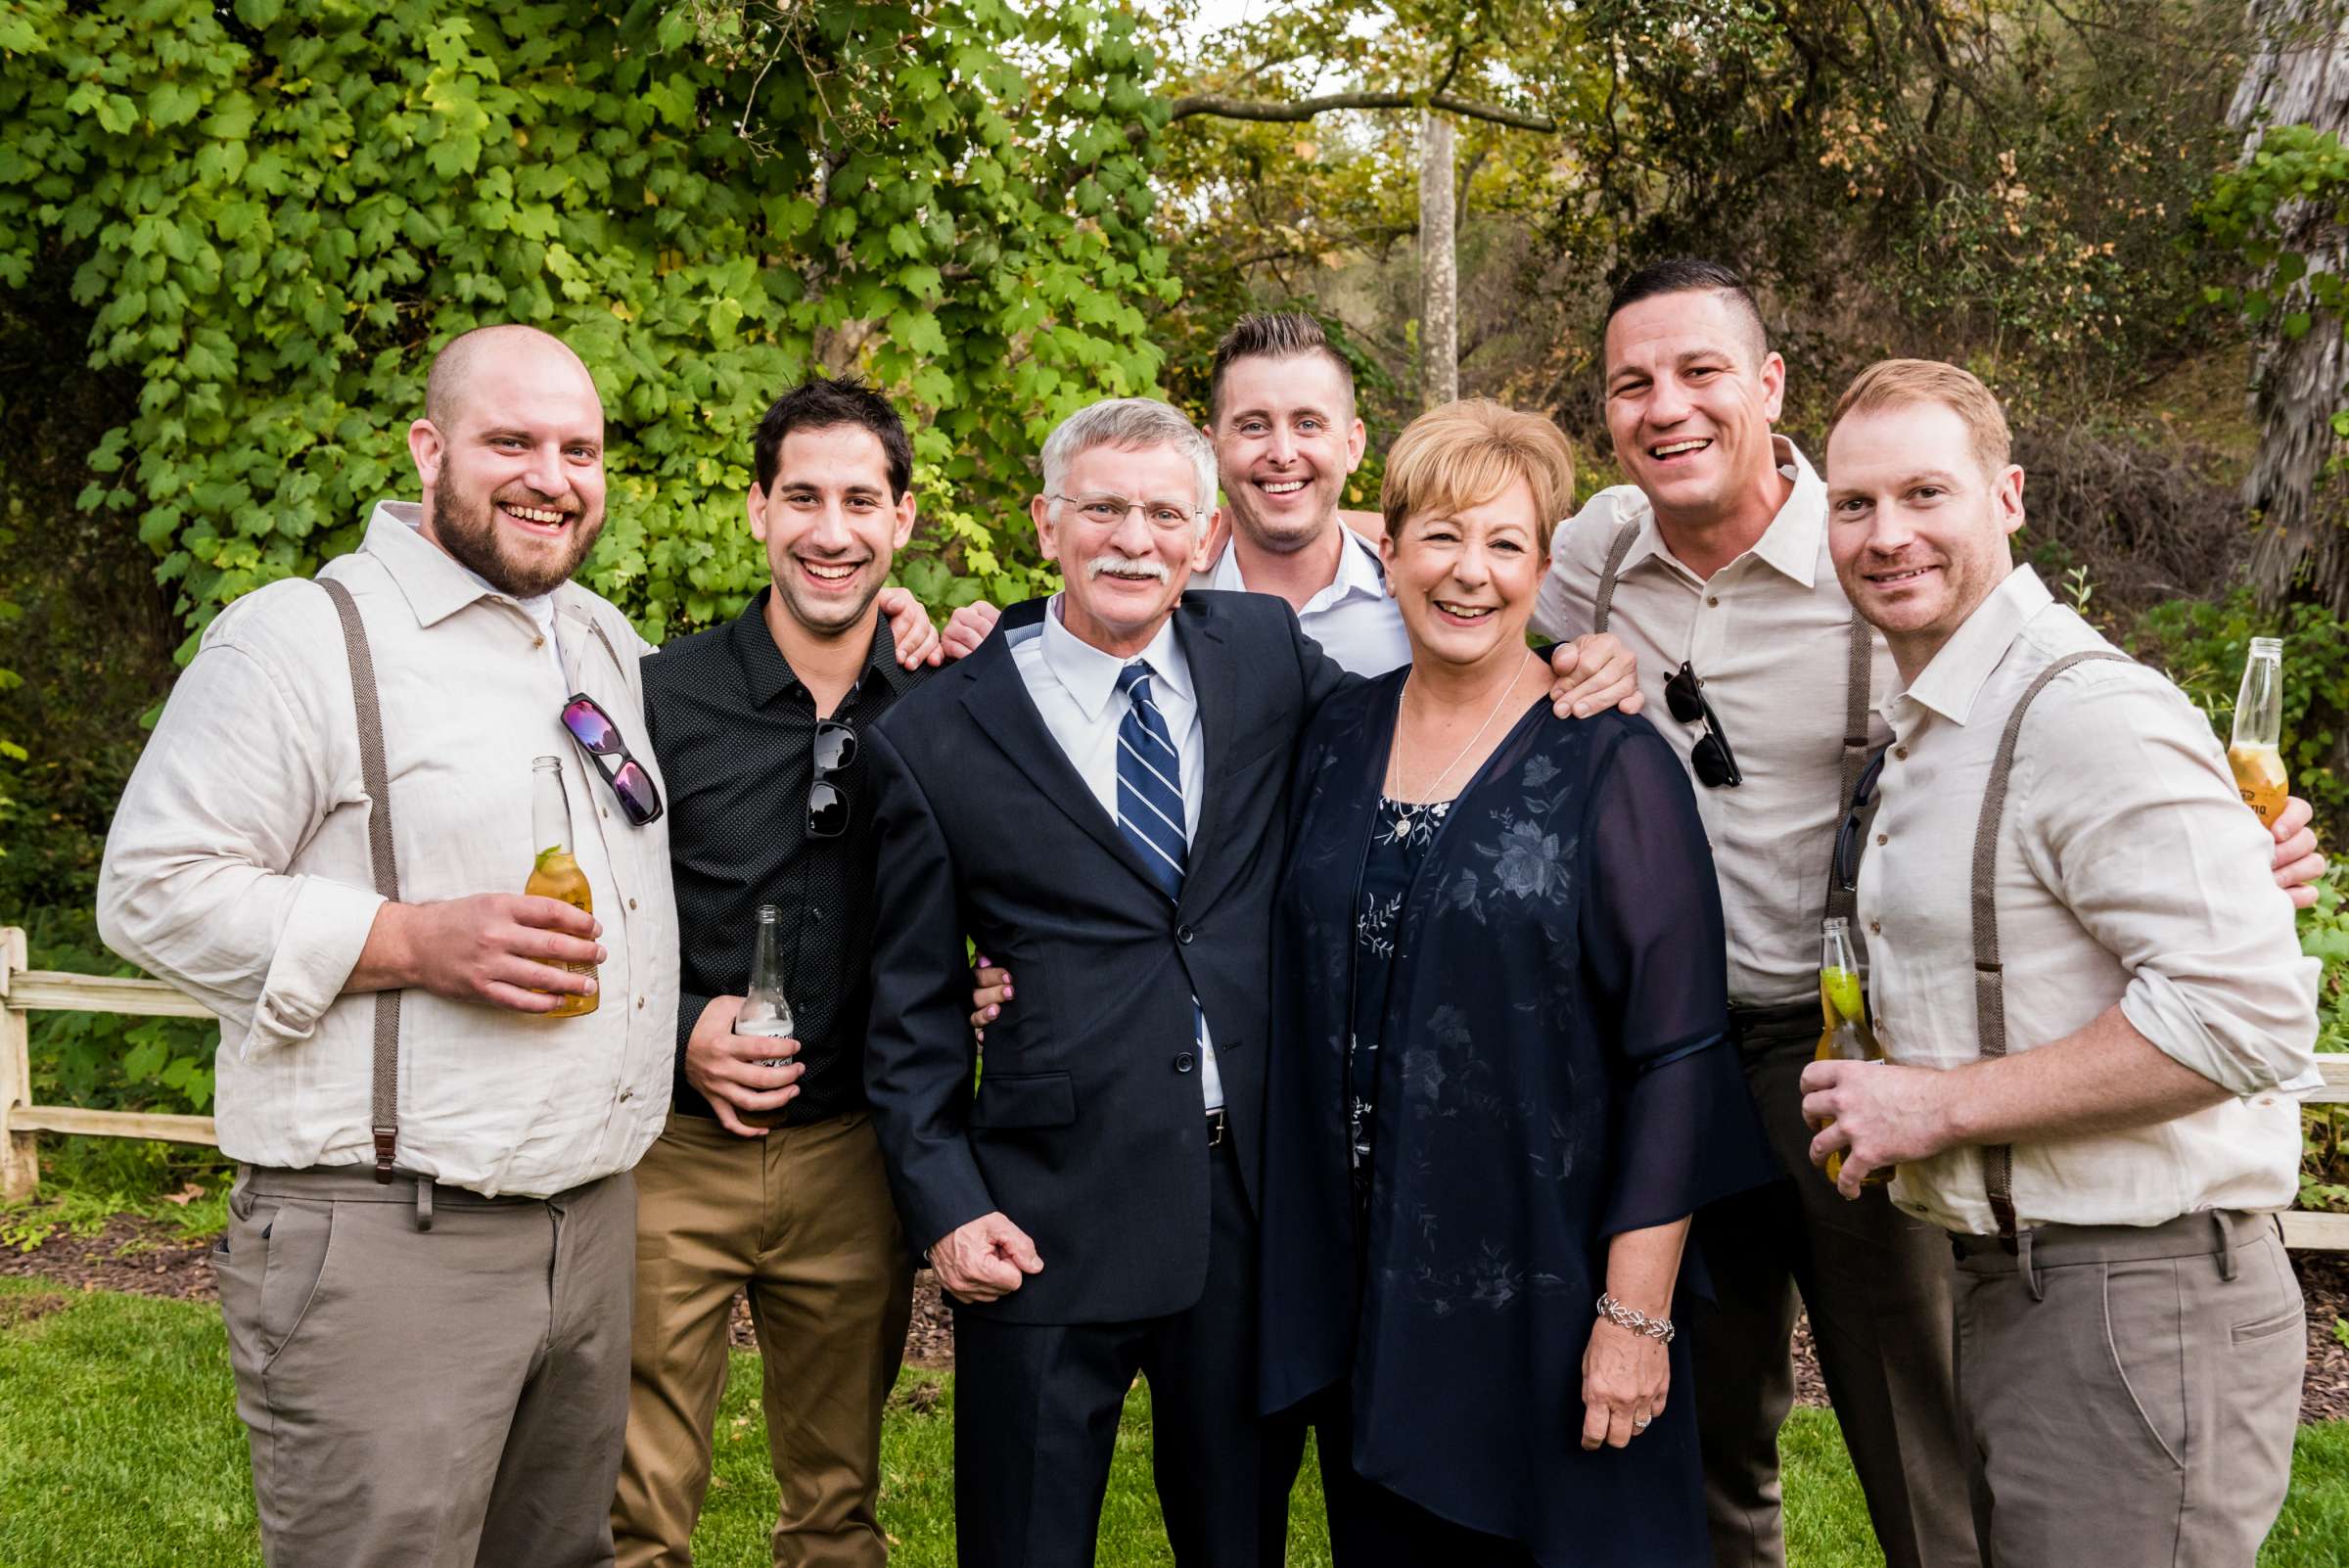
left=864, top=591, right=1351, bottom=1324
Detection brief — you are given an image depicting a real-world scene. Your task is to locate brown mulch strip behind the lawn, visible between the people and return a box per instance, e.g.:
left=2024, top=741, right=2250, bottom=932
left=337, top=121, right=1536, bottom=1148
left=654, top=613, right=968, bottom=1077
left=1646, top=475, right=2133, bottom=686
left=14, top=1216, right=2349, bottom=1420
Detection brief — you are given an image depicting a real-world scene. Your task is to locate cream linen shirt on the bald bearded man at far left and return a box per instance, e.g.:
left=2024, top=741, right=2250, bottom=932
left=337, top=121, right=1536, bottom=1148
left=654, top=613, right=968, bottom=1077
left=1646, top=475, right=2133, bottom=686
left=99, top=502, right=685, bottom=1195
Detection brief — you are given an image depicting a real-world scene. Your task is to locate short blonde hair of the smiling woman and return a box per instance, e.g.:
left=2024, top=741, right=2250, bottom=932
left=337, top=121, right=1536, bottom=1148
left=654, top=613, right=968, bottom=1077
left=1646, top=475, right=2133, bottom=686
left=1379, top=396, right=1574, bottom=556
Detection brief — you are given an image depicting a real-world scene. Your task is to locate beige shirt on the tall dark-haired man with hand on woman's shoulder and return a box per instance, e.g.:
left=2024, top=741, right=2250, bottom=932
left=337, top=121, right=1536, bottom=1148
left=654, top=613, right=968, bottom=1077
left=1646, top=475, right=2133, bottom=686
left=1534, top=437, right=1898, bottom=1007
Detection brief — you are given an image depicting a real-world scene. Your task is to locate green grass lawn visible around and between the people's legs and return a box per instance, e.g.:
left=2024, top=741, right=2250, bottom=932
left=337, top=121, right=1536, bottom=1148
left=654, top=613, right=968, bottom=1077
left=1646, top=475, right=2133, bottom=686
left=0, top=1279, right=2349, bottom=1568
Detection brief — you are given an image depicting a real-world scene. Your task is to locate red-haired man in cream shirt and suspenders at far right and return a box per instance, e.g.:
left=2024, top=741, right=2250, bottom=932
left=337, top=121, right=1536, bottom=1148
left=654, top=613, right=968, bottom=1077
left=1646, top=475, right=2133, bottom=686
left=1802, top=359, right=2319, bottom=1568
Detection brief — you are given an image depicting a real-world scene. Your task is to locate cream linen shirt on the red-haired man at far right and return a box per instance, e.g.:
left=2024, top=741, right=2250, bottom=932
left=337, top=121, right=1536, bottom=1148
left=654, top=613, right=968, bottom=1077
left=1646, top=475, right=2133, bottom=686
left=1861, top=566, right=2321, bottom=1234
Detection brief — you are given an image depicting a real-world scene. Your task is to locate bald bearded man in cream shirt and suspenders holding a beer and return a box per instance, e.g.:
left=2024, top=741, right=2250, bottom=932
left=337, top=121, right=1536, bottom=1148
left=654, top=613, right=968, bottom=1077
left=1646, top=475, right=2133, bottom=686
left=99, top=326, right=676, bottom=1568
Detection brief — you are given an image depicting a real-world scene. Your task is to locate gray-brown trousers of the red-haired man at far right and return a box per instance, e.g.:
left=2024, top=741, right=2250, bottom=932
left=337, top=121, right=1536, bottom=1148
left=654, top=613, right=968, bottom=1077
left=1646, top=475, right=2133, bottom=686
left=1957, top=1211, right=2307, bottom=1568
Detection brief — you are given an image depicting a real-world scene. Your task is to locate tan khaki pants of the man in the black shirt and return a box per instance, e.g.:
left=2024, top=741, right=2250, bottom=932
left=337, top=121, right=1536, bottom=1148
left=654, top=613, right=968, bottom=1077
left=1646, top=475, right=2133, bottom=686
left=611, top=1113, right=914, bottom=1568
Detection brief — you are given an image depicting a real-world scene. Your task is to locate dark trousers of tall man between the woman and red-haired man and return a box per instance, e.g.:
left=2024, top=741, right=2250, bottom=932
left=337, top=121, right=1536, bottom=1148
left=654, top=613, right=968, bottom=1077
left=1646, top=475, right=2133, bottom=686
left=1684, top=1007, right=1980, bottom=1568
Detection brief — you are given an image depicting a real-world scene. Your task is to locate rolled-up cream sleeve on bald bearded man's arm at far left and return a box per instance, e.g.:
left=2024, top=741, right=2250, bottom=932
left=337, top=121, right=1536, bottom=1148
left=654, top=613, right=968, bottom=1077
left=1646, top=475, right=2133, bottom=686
left=99, top=638, right=383, bottom=1059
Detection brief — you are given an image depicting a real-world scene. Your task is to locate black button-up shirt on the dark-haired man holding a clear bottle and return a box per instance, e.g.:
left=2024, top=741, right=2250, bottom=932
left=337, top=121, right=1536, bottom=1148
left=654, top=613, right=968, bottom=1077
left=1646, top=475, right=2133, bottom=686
left=644, top=587, right=930, bottom=1125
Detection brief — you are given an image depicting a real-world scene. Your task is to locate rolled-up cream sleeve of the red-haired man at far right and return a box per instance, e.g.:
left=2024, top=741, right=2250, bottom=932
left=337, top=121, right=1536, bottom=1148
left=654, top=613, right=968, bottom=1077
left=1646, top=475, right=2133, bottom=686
left=2013, top=680, right=2321, bottom=1096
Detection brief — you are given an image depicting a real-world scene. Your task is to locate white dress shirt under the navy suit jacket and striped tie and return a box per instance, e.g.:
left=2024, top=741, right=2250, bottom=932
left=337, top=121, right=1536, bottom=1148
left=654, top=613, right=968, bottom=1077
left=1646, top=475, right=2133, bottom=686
left=1010, top=594, right=1223, bottom=1110
